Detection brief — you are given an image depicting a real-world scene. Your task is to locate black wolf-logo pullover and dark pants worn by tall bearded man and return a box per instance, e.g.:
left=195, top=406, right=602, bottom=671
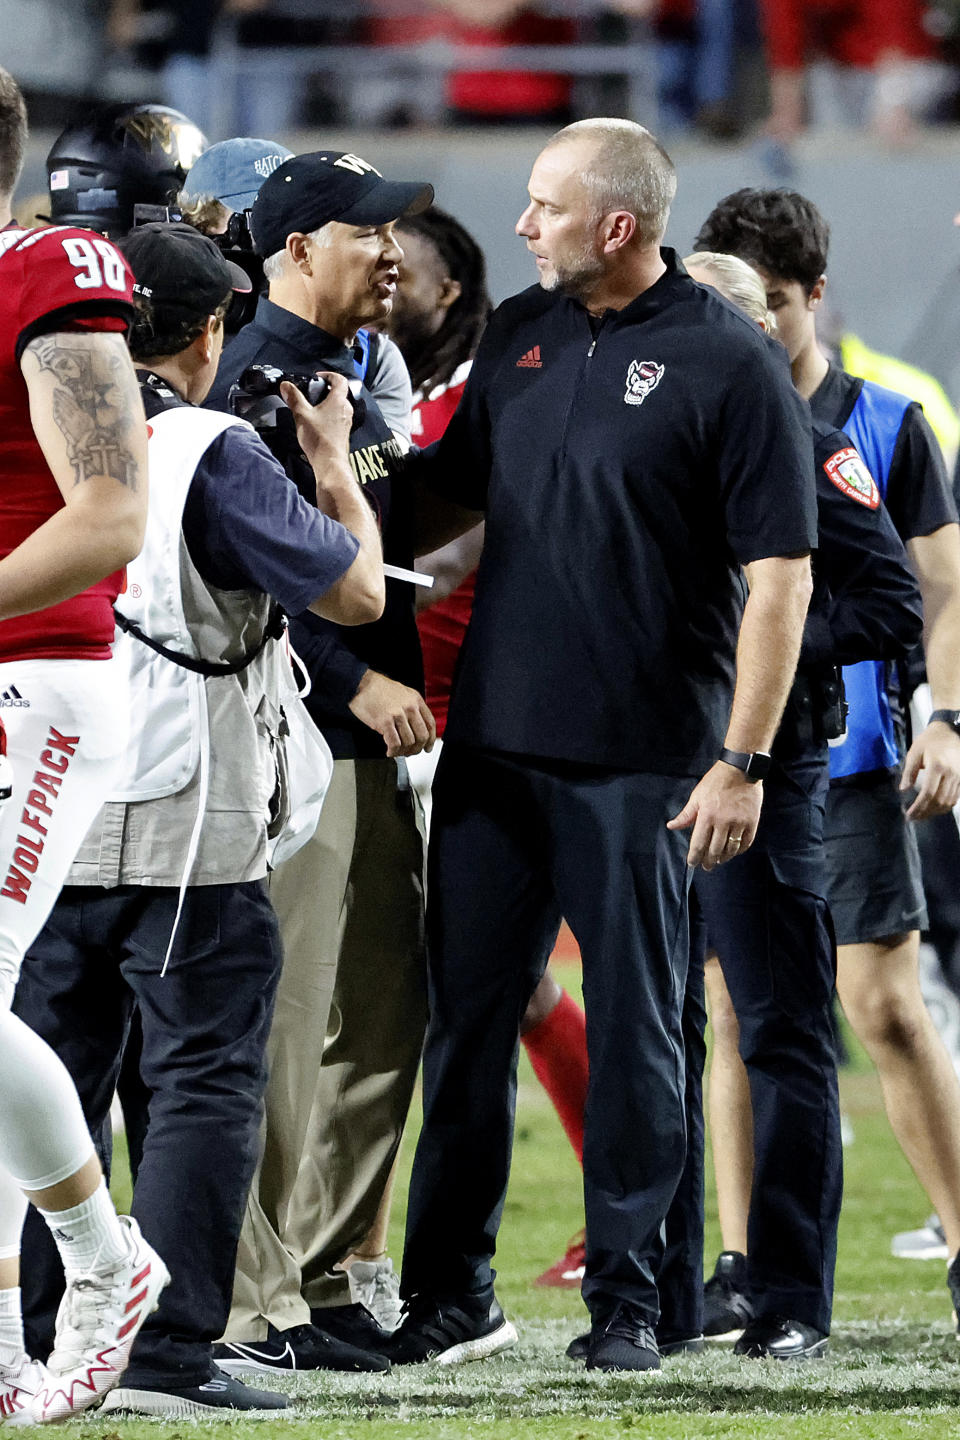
left=402, top=251, right=816, bottom=1323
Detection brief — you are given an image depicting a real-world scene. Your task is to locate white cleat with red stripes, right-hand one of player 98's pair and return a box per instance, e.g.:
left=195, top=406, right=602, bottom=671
left=33, top=1215, right=170, bottom=1424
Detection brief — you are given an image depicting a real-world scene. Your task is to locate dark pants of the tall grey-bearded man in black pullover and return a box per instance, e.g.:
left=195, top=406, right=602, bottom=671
left=402, top=744, right=692, bottom=1323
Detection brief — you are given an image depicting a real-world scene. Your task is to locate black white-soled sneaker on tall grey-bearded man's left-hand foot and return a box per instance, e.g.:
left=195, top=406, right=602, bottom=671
left=387, top=1295, right=517, bottom=1365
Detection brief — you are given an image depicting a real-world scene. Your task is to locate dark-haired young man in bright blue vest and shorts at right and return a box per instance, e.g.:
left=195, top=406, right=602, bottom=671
left=697, top=190, right=960, bottom=1336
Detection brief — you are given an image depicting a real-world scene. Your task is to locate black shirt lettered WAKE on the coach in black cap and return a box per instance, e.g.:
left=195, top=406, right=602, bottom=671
left=206, top=298, right=423, bottom=759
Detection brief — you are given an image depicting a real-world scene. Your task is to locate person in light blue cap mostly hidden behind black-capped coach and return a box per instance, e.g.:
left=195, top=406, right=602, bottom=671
left=178, top=137, right=413, bottom=441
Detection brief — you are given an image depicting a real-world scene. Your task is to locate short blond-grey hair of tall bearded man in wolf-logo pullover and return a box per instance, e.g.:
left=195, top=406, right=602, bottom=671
left=545, top=118, right=676, bottom=245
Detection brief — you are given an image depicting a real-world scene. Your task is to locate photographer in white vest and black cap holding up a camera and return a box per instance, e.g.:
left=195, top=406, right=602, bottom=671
left=16, top=225, right=384, bottom=1416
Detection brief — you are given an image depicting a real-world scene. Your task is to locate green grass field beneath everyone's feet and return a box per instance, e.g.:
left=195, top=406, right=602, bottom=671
left=22, top=971, right=960, bottom=1440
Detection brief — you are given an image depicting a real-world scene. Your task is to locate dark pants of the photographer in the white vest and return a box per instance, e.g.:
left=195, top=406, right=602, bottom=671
left=14, top=881, right=281, bottom=1385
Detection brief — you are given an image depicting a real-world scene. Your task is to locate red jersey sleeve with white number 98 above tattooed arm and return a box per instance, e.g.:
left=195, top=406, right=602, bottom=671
left=7, top=226, right=134, bottom=360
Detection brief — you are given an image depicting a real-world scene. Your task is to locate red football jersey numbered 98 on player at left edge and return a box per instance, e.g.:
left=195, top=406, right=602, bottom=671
left=0, top=226, right=134, bottom=660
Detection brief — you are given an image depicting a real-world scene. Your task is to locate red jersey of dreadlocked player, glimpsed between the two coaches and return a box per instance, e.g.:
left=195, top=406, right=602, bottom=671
left=410, top=360, right=476, bottom=734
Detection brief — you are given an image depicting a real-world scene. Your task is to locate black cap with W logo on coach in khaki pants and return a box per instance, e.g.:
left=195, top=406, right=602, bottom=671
left=250, top=150, right=433, bottom=256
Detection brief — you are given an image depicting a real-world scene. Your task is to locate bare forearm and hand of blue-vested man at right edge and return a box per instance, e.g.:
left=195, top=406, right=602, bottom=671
left=901, top=524, right=960, bottom=819
